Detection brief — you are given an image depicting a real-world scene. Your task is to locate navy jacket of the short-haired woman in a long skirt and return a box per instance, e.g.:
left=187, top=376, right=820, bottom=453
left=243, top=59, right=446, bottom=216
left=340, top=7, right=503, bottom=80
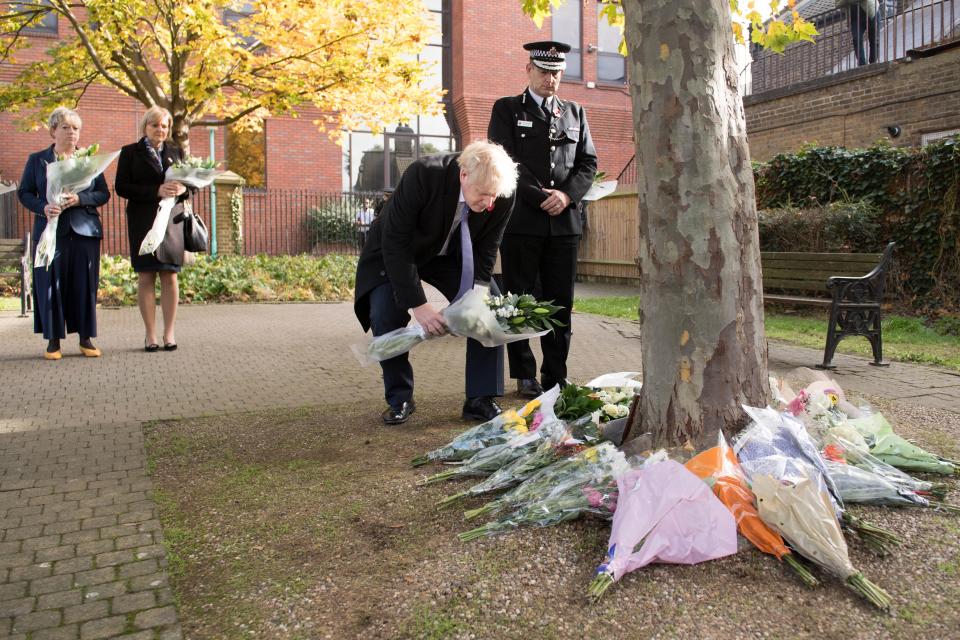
left=17, top=145, right=110, bottom=243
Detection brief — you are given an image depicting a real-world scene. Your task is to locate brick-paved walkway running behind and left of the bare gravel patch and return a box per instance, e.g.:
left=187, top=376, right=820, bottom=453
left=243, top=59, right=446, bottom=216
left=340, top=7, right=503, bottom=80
left=0, top=294, right=960, bottom=640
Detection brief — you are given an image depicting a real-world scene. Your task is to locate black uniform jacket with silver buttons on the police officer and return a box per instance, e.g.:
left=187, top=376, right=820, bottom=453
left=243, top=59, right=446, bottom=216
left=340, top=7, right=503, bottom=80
left=487, top=91, right=597, bottom=236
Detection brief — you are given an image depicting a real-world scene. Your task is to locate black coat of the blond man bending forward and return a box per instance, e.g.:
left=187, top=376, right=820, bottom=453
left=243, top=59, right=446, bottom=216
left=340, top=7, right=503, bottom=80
left=354, top=153, right=514, bottom=331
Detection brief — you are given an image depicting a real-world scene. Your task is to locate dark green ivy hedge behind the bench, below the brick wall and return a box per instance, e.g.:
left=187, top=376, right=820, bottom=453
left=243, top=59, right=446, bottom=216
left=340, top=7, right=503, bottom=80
left=755, top=136, right=960, bottom=311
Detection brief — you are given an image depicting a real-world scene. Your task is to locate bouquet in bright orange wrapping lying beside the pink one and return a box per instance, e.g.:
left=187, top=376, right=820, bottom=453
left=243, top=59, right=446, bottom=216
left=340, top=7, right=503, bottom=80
left=685, top=433, right=818, bottom=587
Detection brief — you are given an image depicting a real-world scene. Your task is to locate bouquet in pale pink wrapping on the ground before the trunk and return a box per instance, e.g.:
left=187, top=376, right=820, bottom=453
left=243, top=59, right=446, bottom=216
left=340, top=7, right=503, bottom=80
left=589, top=460, right=737, bottom=599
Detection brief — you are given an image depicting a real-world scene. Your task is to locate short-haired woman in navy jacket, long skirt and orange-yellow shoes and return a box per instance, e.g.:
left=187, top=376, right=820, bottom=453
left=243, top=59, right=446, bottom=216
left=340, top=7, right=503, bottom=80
left=17, top=107, right=110, bottom=360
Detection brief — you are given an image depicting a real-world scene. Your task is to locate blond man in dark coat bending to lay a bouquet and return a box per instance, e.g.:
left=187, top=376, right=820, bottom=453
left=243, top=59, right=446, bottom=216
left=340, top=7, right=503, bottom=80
left=354, top=141, right=517, bottom=424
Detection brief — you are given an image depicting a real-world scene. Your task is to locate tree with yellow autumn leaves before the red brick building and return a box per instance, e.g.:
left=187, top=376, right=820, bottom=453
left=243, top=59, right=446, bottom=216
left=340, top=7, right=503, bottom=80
left=0, top=0, right=441, bottom=152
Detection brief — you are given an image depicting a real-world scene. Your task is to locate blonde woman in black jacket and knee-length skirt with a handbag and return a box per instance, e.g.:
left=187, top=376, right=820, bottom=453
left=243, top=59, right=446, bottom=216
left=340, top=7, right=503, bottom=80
left=115, top=106, right=190, bottom=352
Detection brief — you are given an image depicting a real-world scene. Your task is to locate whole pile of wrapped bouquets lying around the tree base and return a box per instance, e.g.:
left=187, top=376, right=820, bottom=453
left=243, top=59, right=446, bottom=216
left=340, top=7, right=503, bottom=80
left=413, top=374, right=960, bottom=610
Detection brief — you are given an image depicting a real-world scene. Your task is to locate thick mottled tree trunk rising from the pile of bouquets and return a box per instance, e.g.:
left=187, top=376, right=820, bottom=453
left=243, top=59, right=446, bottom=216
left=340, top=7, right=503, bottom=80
left=623, top=0, right=769, bottom=446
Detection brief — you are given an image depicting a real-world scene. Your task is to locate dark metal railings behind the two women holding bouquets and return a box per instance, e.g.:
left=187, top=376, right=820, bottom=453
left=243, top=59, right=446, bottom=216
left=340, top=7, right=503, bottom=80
left=0, top=189, right=210, bottom=256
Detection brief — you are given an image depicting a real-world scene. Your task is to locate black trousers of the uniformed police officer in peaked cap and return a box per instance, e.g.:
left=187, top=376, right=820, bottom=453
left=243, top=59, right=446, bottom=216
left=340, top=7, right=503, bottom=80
left=500, top=234, right=580, bottom=387
